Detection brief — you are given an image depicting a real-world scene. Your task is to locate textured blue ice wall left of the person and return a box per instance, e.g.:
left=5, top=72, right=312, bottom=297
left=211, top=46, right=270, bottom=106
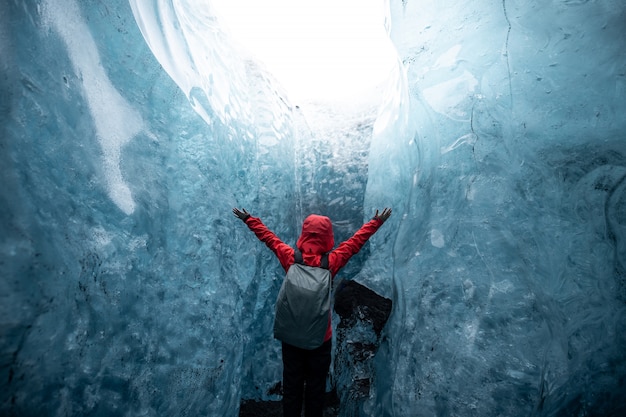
left=0, top=1, right=295, bottom=416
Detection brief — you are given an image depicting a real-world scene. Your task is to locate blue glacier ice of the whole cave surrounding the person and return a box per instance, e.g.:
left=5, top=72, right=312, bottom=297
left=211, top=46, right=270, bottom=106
left=0, top=0, right=626, bottom=417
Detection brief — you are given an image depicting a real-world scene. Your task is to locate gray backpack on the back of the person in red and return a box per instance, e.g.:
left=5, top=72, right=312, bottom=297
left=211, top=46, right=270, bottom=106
left=274, top=249, right=332, bottom=350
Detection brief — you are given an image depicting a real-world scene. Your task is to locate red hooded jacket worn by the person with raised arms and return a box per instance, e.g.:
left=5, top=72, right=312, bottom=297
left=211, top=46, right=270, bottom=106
left=246, top=214, right=383, bottom=341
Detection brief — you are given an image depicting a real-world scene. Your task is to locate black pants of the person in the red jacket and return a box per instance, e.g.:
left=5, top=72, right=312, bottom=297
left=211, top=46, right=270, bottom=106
left=283, top=340, right=332, bottom=417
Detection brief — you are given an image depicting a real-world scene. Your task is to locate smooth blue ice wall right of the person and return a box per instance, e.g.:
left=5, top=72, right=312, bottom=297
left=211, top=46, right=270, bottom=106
left=359, top=1, right=626, bottom=416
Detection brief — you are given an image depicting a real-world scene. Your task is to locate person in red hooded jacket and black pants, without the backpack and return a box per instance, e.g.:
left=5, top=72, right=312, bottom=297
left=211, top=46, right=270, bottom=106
left=233, top=208, right=391, bottom=417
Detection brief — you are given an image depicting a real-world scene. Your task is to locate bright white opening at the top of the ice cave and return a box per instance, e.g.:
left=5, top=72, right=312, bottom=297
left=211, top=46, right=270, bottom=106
left=211, top=0, right=396, bottom=101
